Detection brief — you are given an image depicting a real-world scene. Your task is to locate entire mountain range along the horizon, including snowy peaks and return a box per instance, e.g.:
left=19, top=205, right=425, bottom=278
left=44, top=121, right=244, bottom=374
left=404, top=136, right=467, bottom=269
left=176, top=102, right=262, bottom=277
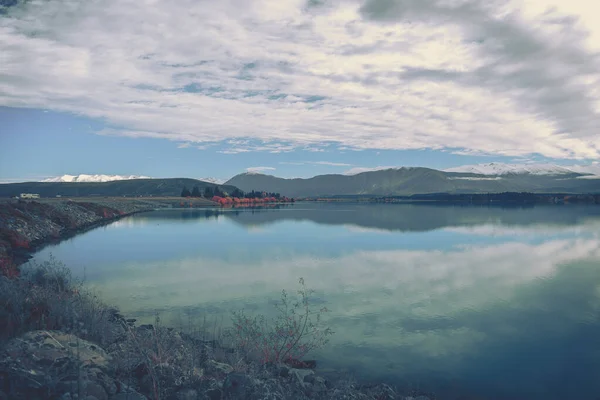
left=0, top=163, right=600, bottom=198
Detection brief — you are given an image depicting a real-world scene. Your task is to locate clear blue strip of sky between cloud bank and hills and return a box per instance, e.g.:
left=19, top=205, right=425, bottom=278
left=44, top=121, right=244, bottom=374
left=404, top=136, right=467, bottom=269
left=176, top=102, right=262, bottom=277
left=0, top=107, right=536, bottom=182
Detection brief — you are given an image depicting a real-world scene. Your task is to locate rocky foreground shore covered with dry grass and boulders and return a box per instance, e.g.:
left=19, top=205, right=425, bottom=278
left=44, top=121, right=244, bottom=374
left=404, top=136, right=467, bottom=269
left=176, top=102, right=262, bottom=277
left=0, top=262, right=433, bottom=400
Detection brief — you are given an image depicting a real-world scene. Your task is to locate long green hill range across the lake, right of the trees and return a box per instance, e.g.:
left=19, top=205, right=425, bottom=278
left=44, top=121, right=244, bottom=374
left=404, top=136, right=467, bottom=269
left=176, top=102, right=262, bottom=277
left=226, top=168, right=600, bottom=197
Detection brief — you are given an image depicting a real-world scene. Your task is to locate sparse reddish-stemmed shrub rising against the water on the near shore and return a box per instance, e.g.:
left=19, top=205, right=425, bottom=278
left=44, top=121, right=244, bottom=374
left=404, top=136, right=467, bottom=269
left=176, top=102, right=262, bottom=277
left=226, top=278, right=333, bottom=363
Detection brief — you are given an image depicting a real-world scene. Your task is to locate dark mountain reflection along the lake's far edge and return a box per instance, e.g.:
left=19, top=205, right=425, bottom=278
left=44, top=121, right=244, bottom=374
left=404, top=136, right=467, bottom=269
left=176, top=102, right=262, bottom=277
left=136, top=203, right=600, bottom=232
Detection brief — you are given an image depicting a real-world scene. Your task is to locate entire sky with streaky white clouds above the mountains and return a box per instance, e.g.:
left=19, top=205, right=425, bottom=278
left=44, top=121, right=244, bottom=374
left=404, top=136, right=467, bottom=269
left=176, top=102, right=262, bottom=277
left=0, top=0, right=600, bottom=182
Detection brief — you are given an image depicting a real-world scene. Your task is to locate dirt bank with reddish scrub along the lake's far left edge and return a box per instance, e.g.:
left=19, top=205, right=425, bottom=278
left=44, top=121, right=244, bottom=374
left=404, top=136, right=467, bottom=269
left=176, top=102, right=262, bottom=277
left=0, top=197, right=215, bottom=267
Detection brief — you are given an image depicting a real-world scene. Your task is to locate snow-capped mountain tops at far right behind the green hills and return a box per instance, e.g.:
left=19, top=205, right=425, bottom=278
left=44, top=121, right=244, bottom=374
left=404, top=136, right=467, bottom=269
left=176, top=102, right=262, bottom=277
left=444, top=163, right=600, bottom=175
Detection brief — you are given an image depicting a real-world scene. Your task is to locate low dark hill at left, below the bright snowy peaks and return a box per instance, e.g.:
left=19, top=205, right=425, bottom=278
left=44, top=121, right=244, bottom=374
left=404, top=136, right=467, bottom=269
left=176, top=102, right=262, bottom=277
left=0, top=178, right=235, bottom=197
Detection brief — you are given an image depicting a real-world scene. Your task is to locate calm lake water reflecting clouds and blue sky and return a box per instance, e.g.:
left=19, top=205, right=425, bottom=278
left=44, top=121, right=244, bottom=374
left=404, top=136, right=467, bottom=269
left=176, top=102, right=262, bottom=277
left=25, top=204, right=600, bottom=400
